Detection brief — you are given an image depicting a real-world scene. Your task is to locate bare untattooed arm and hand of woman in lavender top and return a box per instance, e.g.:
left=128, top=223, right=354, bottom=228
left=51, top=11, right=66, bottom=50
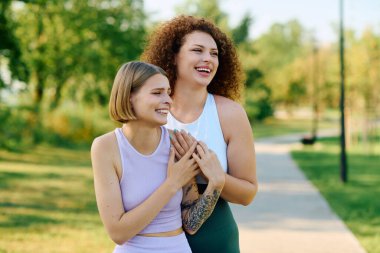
left=91, top=134, right=197, bottom=244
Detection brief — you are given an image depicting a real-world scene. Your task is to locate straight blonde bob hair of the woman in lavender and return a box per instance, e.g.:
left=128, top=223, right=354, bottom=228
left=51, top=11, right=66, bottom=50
left=109, top=61, right=168, bottom=123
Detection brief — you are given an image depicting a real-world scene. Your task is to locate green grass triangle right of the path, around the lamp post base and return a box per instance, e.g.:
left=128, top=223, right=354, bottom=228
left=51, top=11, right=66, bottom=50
left=292, top=138, right=380, bottom=253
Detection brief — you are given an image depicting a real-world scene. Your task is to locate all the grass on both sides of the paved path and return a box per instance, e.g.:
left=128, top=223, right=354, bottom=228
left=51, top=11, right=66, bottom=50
left=0, top=115, right=374, bottom=253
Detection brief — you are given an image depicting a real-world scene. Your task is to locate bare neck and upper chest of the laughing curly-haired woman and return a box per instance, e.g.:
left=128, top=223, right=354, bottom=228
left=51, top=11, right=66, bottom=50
left=170, top=83, right=208, bottom=123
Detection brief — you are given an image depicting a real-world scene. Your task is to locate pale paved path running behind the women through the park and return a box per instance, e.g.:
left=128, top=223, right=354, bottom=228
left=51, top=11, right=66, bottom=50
left=231, top=135, right=365, bottom=253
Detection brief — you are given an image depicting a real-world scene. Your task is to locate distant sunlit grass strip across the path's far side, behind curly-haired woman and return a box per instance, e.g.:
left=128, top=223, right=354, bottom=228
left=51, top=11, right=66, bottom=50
left=252, top=118, right=339, bottom=139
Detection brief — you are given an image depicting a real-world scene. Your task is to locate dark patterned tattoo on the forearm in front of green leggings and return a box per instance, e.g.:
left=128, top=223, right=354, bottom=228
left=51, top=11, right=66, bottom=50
left=181, top=186, right=221, bottom=232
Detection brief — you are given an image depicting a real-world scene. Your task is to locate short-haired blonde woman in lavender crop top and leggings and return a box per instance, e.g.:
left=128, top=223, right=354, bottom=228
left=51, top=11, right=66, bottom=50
left=91, top=62, right=224, bottom=253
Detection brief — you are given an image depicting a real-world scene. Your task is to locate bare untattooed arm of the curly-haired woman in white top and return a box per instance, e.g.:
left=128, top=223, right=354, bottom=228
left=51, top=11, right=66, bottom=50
left=215, top=96, right=258, bottom=205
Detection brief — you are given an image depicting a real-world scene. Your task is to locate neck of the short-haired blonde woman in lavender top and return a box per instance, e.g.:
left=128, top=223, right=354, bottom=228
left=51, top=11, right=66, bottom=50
left=122, top=120, right=161, bottom=155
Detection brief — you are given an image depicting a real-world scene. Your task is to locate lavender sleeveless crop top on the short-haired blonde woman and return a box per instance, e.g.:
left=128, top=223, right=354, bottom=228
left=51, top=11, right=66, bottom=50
left=115, top=127, right=182, bottom=234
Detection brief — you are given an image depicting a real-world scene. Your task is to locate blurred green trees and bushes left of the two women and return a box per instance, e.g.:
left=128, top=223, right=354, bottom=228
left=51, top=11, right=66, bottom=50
left=0, top=0, right=146, bottom=146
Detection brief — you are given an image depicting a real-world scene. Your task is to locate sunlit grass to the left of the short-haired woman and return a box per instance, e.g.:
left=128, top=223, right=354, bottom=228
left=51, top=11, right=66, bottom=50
left=0, top=143, right=114, bottom=253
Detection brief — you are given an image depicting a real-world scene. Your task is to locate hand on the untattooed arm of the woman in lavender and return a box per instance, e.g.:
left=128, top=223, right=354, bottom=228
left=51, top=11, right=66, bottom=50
left=166, top=142, right=200, bottom=190
